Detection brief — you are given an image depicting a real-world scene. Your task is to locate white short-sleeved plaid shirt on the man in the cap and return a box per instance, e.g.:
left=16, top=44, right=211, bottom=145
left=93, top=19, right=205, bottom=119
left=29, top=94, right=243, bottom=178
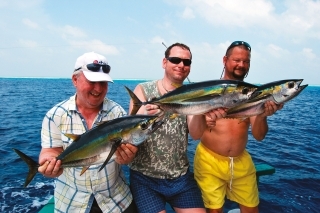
left=41, top=95, right=132, bottom=213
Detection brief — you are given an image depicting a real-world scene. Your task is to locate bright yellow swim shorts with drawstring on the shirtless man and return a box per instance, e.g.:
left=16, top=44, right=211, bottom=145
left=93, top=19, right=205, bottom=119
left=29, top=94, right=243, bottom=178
left=194, top=142, right=259, bottom=209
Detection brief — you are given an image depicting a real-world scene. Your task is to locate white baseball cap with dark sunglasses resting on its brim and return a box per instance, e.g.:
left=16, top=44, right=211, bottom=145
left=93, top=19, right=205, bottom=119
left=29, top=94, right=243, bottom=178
left=74, top=52, right=113, bottom=82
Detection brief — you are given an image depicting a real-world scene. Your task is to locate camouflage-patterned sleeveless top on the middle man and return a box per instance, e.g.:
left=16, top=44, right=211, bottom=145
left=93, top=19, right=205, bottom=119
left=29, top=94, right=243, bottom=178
left=129, top=81, right=189, bottom=179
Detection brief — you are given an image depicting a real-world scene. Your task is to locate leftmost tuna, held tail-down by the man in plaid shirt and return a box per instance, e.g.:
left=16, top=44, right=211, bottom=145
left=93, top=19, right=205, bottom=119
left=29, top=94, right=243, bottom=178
left=13, top=115, right=163, bottom=187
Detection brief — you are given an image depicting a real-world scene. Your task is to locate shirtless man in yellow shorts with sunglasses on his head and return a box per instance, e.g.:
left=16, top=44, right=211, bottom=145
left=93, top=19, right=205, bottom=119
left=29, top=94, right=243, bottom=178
left=188, top=41, right=283, bottom=213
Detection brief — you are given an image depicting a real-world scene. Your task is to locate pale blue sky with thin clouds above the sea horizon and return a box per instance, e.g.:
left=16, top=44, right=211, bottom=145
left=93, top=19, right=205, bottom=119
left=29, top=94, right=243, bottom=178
left=0, top=0, right=320, bottom=85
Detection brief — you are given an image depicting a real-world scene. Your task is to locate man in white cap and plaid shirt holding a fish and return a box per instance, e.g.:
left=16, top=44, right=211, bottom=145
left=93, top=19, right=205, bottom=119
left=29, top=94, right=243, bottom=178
left=38, top=52, right=138, bottom=213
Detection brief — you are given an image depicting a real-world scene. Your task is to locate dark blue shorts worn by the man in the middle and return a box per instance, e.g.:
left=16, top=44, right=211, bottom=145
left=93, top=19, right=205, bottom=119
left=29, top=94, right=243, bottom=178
left=130, top=170, right=204, bottom=212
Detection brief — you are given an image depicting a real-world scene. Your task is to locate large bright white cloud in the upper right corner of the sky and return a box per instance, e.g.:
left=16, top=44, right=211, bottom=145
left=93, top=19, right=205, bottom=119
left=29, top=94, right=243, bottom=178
left=176, top=0, right=320, bottom=39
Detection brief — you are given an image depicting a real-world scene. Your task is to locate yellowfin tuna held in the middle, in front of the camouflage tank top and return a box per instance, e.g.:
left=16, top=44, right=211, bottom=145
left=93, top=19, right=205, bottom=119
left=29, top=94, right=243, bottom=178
left=126, top=80, right=258, bottom=115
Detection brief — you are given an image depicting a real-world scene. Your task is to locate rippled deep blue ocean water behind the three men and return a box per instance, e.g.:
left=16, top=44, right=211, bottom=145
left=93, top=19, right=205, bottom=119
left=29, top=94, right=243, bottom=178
left=0, top=78, right=320, bottom=213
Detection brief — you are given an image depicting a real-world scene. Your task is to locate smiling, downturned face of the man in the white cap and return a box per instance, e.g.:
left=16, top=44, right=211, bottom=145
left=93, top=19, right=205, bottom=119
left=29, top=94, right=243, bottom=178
left=72, top=72, right=108, bottom=109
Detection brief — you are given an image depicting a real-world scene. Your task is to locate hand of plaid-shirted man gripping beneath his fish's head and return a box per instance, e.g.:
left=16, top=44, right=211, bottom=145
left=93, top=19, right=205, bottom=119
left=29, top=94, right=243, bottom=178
left=115, top=143, right=138, bottom=164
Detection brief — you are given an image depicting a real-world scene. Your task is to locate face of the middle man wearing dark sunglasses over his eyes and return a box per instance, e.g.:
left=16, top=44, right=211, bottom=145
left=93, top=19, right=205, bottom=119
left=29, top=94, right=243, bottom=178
left=162, top=46, right=191, bottom=84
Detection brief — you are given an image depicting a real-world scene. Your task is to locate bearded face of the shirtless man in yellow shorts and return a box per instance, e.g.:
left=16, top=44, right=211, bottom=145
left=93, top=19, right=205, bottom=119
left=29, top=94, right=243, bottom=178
left=223, top=47, right=251, bottom=80
